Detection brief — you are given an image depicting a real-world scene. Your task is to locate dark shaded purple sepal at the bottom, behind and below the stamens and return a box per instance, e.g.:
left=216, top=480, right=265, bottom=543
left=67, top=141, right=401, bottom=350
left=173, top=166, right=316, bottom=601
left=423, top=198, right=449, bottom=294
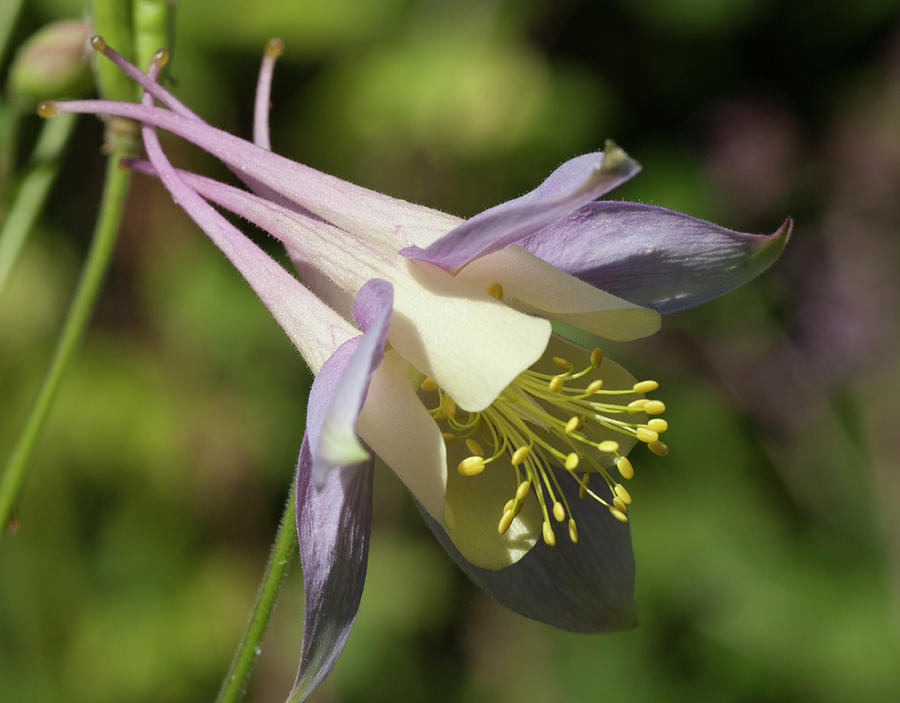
left=419, top=472, right=637, bottom=632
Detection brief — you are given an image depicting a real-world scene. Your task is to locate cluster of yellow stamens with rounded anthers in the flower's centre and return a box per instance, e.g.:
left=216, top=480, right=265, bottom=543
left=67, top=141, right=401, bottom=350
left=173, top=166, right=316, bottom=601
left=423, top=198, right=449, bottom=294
left=421, top=294, right=669, bottom=546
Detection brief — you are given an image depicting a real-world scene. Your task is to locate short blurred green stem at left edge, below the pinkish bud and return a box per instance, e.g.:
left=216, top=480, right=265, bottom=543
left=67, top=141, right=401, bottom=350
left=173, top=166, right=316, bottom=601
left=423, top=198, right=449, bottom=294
left=0, top=115, right=75, bottom=293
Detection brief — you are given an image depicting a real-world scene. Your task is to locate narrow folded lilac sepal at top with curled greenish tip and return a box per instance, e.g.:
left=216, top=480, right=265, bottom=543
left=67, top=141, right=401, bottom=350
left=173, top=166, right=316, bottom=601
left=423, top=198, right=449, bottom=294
left=401, top=142, right=640, bottom=270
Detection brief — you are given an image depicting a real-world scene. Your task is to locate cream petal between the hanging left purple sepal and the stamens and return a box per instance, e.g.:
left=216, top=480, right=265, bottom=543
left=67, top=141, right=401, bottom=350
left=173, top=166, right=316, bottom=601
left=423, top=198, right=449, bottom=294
left=356, top=351, right=447, bottom=523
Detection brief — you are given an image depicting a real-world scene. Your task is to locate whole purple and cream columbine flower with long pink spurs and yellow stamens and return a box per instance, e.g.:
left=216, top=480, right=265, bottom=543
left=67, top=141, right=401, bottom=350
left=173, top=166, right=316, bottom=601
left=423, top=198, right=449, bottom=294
left=39, top=37, right=791, bottom=697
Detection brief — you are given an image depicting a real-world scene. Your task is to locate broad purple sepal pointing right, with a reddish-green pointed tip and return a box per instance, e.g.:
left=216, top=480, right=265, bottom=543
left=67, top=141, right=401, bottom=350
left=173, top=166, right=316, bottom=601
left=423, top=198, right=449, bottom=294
left=521, top=201, right=793, bottom=313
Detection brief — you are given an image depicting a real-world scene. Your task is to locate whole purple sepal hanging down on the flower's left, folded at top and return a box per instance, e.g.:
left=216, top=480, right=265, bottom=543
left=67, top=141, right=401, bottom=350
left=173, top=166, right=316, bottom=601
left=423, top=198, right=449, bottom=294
left=294, top=279, right=393, bottom=700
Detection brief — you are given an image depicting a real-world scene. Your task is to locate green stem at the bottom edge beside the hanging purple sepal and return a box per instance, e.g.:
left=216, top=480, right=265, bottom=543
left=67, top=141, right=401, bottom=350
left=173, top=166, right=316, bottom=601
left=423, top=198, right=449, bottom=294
left=216, top=489, right=297, bottom=703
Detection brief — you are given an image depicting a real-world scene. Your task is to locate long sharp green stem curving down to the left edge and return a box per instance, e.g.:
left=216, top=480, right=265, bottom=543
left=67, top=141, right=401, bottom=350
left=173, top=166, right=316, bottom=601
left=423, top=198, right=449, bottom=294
left=0, top=147, right=131, bottom=529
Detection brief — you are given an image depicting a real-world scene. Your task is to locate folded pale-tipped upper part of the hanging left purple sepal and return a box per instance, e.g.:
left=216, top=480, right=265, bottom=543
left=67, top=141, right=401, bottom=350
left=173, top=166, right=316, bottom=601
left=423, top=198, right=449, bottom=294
left=306, top=279, right=393, bottom=487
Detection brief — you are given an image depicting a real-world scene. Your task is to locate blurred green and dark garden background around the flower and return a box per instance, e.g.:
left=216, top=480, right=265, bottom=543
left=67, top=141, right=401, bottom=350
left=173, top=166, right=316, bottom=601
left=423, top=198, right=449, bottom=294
left=0, top=0, right=900, bottom=703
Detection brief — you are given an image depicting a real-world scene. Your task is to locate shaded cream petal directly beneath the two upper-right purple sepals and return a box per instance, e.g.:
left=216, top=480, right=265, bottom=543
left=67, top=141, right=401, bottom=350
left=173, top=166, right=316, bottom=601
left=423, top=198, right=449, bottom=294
left=456, top=245, right=660, bottom=342
